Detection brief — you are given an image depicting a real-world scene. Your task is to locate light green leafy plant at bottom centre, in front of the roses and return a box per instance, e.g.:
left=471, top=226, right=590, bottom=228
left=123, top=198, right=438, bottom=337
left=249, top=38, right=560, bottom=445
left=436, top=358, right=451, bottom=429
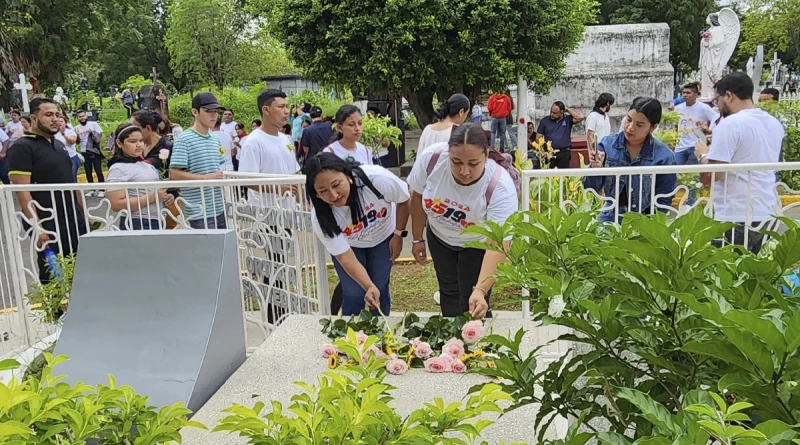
left=214, top=329, right=511, bottom=445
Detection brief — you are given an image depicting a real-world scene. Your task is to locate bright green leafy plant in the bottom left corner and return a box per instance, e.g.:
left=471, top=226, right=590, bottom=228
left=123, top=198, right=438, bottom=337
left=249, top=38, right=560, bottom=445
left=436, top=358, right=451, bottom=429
left=0, top=354, right=205, bottom=445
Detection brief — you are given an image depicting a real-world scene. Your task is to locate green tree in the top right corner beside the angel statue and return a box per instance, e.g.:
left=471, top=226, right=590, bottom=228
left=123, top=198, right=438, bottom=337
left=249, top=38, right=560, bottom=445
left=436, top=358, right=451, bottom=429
left=736, top=0, right=800, bottom=65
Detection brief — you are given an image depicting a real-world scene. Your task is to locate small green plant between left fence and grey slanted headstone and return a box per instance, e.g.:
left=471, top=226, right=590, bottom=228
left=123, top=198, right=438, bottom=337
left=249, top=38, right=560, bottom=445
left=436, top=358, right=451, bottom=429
left=26, top=254, right=75, bottom=324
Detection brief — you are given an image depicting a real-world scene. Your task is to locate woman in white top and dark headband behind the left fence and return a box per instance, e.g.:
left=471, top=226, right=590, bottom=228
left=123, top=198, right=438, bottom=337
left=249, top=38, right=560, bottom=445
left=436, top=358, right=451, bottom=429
left=107, top=124, right=175, bottom=230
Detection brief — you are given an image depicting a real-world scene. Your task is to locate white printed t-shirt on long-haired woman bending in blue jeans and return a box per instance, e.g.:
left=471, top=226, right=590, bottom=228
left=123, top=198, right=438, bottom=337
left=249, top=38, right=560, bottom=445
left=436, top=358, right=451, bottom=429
left=311, top=165, right=409, bottom=256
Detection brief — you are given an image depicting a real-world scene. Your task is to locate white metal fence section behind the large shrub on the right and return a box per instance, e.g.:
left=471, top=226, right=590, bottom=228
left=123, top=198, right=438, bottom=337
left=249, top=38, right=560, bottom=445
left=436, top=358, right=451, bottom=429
left=520, top=162, right=800, bottom=317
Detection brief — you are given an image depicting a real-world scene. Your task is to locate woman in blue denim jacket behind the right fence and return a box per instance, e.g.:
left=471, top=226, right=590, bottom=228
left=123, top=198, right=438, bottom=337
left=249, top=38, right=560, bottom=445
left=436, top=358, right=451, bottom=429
left=583, top=97, right=678, bottom=222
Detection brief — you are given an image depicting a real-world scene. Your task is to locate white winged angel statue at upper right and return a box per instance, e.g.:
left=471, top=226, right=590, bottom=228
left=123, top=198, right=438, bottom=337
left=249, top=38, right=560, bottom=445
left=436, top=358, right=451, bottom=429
left=700, top=8, right=741, bottom=97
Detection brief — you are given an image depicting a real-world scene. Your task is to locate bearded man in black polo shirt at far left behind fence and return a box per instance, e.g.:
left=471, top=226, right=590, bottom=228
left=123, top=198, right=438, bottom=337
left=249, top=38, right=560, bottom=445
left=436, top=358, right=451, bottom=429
left=8, top=98, right=86, bottom=283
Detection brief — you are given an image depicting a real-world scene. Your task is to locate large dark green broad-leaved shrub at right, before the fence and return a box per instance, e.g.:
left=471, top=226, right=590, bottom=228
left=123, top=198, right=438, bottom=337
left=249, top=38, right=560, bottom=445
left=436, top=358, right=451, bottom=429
left=468, top=208, right=800, bottom=440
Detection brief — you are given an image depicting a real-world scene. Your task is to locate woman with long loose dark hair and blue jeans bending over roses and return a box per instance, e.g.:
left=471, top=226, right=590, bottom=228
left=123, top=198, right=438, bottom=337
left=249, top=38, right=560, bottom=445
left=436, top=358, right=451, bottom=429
left=303, top=152, right=409, bottom=315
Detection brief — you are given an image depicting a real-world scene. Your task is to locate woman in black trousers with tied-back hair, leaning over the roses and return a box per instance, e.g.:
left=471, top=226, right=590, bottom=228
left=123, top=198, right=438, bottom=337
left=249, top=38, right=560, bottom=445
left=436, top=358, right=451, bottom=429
left=408, top=123, right=518, bottom=317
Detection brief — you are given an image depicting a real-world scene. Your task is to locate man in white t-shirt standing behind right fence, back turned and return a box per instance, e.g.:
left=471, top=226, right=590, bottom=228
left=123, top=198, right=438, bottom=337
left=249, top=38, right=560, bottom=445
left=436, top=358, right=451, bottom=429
left=696, top=73, right=786, bottom=253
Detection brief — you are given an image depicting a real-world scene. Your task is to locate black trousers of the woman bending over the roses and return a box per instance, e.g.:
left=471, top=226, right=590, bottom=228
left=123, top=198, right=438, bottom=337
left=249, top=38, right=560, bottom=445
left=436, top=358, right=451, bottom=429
left=427, top=227, right=492, bottom=317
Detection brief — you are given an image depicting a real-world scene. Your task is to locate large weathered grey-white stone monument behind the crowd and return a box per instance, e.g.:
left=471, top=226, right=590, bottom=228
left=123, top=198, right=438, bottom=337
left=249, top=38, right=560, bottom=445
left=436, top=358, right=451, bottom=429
left=528, top=23, right=675, bottom=129
